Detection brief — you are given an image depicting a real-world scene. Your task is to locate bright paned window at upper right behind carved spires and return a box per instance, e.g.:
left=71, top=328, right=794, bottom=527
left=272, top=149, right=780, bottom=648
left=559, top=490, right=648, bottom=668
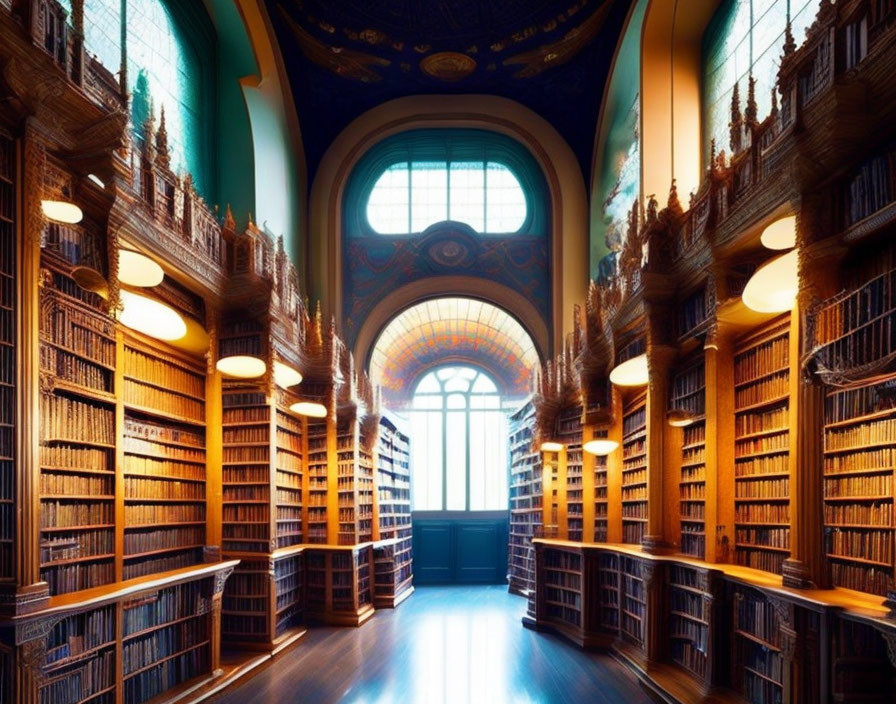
left=703, top=0, right=818, bottom=157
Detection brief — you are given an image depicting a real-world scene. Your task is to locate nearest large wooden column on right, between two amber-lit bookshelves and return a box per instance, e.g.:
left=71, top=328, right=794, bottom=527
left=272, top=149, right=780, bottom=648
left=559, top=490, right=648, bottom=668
left=783, top=208, right=843, bottom=588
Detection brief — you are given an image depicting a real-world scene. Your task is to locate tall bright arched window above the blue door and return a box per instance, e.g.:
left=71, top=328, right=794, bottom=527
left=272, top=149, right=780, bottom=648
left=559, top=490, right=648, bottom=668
left=409, top=366, right=508, bottom=511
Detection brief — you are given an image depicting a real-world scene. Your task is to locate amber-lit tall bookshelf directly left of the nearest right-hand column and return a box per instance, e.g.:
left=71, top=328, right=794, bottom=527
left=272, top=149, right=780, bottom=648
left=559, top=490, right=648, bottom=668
left=734, top=316, right=790, bottom=574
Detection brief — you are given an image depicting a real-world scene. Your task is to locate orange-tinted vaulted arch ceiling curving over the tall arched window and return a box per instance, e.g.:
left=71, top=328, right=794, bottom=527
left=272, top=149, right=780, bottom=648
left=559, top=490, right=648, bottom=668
left=370, top=297, right=539, bottom=408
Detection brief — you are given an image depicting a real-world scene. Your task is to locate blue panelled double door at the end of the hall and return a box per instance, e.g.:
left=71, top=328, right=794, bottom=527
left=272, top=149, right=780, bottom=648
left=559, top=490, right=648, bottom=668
left=413, top=511, right=510, bottom=584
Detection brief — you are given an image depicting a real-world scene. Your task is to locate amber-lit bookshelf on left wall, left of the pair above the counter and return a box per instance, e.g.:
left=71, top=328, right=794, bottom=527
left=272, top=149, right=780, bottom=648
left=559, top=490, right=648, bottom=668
left=39, top=262, right=117, bottom=595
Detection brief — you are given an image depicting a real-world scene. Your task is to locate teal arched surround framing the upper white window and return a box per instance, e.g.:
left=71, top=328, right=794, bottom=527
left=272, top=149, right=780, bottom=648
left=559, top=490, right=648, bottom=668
left=342, top=128, right=551, bottom=241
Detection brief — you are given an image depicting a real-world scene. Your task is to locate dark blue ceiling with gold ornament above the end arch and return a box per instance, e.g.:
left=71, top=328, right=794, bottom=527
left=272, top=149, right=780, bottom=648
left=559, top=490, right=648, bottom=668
left=265, top=0, right=631, bottom=186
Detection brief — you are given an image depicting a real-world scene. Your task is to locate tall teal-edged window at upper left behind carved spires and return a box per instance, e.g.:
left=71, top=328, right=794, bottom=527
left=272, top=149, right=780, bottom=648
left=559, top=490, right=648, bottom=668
left=84, top=0, right=213, bottom=198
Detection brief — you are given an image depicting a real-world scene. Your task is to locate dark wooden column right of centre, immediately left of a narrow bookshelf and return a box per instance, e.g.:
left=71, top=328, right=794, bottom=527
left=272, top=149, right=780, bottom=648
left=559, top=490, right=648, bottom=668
left=641, top=305, right=675, bottom=553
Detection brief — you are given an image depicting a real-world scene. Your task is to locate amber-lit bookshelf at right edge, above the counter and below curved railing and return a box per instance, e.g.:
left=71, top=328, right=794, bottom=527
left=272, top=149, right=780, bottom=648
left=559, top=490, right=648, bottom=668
left=824, top=375, right=896, bottom=596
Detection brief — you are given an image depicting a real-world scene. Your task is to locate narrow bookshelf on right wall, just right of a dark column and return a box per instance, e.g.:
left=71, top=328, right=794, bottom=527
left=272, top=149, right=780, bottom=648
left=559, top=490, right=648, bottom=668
left=669, top=355, right=706, bottom=559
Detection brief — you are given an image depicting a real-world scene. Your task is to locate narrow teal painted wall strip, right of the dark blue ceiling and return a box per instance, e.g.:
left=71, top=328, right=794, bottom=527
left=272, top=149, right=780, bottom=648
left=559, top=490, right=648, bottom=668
left=590, top=0, right=649, bottom=278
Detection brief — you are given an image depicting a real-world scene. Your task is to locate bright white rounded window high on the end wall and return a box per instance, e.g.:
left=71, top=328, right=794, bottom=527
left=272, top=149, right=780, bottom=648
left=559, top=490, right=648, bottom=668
left=367, top=160, right=528, bottom=235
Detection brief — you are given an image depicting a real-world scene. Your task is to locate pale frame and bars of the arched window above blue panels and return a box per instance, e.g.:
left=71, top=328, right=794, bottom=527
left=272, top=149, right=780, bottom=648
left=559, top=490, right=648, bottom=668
left=406, top=362, right=510, bottom=513
